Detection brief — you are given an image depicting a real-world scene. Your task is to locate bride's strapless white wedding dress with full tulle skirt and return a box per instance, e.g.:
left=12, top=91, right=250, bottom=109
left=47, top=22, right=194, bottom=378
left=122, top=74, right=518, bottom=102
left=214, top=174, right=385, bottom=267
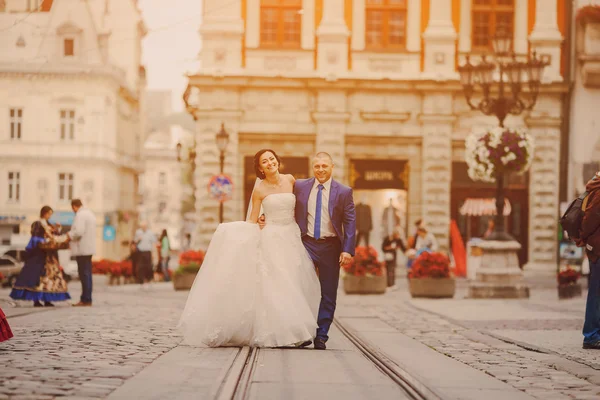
left=179, top=193, right=321, bottom=347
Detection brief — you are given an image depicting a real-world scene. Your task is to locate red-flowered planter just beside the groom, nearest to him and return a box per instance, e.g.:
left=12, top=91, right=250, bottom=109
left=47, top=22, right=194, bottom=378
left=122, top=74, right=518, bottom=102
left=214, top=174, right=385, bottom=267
left=342, top=246, right=387, bottom=294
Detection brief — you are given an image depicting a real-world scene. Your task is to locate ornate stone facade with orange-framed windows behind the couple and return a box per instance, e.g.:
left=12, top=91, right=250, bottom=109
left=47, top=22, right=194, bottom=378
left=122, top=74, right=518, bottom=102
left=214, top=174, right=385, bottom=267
left=184, top=0, right=566, bottom=271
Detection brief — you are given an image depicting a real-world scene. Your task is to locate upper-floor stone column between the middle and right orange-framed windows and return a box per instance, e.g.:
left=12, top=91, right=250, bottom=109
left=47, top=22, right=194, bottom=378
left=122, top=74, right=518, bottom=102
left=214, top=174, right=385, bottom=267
left=423, top=0, right=457, bottom=79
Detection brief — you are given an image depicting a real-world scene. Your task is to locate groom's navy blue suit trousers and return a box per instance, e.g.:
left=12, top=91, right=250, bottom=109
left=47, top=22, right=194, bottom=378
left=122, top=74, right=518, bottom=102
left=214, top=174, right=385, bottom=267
left=302, top=236, right=342, bottom=341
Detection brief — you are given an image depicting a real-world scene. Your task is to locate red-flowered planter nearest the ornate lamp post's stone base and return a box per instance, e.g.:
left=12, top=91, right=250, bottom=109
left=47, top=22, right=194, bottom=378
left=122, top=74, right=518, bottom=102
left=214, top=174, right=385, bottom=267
left=408, top=252, right=456, bottom=298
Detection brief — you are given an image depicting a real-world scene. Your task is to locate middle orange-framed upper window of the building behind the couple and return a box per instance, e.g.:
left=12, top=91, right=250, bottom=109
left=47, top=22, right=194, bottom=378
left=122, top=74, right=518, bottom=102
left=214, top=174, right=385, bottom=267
left=365, top=0, right=406, bottom=49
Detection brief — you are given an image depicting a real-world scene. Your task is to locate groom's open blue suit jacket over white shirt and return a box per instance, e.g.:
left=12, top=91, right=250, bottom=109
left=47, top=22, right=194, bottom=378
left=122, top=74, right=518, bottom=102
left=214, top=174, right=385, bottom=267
left=294, top=178, right=356, bottom=255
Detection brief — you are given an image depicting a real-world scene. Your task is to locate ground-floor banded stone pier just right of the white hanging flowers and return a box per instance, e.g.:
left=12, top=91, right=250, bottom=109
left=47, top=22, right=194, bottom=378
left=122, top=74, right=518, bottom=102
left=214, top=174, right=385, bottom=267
left=525, top=114, right=561, bottom=275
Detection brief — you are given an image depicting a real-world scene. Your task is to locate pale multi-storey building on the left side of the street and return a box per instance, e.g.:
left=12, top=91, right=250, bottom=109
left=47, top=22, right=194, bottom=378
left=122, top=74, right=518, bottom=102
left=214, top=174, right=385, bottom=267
left=0, top=0, right=146, bottom=259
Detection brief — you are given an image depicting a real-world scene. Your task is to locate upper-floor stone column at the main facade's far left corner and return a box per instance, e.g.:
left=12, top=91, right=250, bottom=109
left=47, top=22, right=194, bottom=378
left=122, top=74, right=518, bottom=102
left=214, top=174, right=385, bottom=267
left=199, top=0, right=244, bottom=75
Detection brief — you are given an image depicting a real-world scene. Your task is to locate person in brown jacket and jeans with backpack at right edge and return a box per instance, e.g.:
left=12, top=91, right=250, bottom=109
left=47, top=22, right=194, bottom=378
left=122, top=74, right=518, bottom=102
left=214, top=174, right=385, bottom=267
left=563, top=172, right=600, bottom=350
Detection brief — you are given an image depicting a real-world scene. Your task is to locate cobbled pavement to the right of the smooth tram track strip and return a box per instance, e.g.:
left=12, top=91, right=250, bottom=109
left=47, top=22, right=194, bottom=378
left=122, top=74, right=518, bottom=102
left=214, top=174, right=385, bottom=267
left=338, top=279, right=600, bottom=399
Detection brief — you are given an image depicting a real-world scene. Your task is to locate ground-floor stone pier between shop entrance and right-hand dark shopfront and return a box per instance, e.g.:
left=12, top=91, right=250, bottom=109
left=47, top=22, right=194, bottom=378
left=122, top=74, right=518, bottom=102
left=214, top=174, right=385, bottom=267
left=419, top=94, right=456, bottom=251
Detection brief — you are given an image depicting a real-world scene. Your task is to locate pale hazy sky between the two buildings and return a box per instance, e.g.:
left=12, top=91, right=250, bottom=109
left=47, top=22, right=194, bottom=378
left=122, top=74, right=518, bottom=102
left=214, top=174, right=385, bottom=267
left=138, top=0, right=202, bottom=111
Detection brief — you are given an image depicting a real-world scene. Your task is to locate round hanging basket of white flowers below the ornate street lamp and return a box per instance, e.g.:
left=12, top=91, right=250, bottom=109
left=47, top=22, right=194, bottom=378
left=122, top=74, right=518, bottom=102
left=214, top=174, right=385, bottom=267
left=465, top=127, right=534, bottom=182
